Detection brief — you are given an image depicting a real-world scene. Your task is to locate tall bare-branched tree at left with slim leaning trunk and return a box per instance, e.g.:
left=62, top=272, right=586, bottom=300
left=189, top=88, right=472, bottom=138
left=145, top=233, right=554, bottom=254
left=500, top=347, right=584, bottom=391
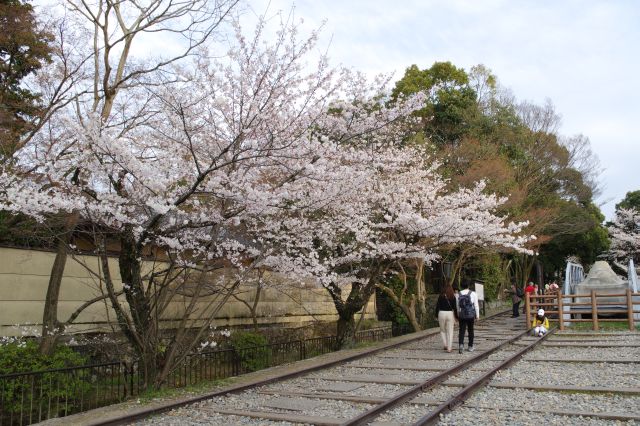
left=14, top=0, right=238, bottom=353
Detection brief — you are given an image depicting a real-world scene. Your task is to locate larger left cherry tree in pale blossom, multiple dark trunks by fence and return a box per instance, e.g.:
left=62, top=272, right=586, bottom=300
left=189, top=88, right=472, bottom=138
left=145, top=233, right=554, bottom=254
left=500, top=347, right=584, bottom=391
left=0, top=11, right=430, bottom=386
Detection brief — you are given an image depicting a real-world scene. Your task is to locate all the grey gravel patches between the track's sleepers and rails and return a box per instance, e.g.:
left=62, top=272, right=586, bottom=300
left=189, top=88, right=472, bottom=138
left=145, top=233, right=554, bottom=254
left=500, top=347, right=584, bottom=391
left=139, top=316, right=640, bottom=426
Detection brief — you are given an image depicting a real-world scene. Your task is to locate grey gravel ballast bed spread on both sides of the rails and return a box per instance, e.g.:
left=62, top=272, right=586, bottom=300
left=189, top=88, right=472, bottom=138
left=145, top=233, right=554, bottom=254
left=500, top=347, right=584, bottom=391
left=125, top=318, right=640, bottom=426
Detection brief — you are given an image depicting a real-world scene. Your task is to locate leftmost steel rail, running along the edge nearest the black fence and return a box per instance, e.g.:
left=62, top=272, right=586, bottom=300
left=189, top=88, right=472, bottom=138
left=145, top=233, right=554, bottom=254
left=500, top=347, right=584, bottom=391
left=87, top=309, right=511, bottom=426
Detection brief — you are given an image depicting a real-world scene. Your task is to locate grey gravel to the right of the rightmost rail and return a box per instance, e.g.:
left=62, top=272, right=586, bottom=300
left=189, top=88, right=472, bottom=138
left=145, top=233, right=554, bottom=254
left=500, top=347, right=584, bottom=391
left=439, top=333, right=640, bottom=426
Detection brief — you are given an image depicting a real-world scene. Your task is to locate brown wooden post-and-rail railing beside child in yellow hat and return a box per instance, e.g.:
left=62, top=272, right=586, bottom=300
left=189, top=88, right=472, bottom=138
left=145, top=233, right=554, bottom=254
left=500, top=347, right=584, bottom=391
left=525, top=290, right=640, bottom=330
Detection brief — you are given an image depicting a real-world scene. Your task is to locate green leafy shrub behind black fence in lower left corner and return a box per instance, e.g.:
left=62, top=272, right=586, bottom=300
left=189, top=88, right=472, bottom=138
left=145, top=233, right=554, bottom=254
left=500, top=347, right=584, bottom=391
left=0, top=341, right=91, bottom=418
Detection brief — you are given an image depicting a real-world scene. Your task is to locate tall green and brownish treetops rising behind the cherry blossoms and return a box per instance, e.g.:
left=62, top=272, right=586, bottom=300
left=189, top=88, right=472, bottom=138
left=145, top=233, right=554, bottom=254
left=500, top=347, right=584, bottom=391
left=392, top=62, right=608, bottom=280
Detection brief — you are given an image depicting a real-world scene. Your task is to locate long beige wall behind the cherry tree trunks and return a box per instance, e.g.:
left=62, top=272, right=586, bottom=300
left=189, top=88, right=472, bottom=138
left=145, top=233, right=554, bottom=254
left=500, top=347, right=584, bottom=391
left=0, top=247, right=375, bottom=336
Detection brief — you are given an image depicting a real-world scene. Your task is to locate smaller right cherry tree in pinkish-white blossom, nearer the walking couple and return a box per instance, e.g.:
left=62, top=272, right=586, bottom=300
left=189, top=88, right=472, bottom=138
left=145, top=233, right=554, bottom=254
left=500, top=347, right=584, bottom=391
left=252, top=146, right=532, bottom=345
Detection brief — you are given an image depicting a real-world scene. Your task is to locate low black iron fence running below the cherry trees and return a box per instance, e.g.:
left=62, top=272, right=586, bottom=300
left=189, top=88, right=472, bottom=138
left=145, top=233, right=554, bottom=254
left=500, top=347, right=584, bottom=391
left=0, top=328, right=406, bottom=426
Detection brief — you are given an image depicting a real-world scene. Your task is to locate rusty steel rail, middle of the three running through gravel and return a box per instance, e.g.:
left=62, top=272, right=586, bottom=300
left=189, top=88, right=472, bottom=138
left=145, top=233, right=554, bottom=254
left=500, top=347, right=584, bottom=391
left=341, top=322, right=529, bottom=426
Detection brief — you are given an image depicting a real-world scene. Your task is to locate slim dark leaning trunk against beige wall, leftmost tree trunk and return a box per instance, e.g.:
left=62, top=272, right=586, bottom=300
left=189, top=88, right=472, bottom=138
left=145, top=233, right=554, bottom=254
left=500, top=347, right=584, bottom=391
left=39, top=212, right=80, bottom=355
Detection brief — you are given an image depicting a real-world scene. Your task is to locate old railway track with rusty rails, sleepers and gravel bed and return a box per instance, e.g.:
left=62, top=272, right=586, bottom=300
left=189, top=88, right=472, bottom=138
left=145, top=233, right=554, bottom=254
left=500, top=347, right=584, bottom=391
left=89, top=315, right=640, bottom=425
